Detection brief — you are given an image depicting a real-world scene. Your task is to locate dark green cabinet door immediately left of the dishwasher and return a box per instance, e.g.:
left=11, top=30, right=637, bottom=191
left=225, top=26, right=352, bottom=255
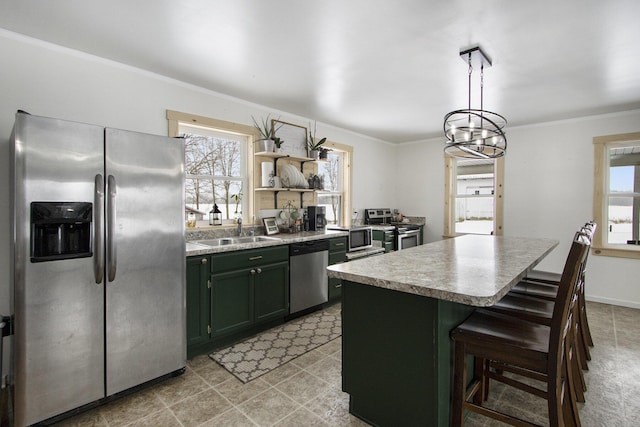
left=253, top=262, right=289, bottom=323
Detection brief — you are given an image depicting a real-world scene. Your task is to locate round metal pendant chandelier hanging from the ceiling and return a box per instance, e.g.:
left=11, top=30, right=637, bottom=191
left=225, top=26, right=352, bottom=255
left=444, top=47, right=507, bottom=159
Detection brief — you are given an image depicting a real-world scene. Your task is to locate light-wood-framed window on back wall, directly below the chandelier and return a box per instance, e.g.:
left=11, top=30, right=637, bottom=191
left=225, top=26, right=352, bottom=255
left=444, top=156, right=504, bottom=237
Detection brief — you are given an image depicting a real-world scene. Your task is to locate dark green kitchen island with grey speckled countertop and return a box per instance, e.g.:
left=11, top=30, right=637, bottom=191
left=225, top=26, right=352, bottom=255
left=328, top=235, right=558, bottom=426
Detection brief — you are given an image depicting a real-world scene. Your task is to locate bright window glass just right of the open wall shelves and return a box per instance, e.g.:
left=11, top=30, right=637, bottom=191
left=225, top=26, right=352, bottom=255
left=318, top=151, right=344, bottom=225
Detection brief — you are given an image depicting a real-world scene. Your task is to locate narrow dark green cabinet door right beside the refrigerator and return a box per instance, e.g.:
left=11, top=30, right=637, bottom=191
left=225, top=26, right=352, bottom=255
left=187, top=256, right=211, bottom=353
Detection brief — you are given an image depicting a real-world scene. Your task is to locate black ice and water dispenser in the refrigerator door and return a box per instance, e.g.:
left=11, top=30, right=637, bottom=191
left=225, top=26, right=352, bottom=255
left=31, top=202, right=92, bottom=262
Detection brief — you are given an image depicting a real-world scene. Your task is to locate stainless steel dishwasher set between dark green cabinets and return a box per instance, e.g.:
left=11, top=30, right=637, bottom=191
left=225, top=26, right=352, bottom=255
left=289, top=239, right=329, bottom=314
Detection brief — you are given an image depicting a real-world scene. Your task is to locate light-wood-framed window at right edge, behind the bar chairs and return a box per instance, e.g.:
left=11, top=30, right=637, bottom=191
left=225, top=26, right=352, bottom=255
left=592, top=133, right=640, bottom=258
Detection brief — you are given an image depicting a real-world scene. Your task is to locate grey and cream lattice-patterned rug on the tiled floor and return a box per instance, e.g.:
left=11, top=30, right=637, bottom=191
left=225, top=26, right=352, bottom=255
left=209, top=310, right=342, bottom=383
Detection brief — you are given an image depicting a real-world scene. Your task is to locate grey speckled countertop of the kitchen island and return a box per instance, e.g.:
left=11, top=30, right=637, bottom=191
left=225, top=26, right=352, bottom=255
left=327, top=235, right=559, bottom=307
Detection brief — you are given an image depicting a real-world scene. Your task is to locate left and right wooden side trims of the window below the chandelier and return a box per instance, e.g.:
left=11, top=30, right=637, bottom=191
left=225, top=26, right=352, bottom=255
left=443, top=154, right=504, bottom=238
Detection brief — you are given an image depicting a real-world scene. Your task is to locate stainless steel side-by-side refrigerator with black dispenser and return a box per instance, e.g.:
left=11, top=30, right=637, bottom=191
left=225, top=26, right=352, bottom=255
left=12, top=112, right=186, bottom=426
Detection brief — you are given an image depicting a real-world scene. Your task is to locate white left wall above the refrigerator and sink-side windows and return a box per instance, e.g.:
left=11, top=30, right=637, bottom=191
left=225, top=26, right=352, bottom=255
left=0, top=29, right=395, bottom=376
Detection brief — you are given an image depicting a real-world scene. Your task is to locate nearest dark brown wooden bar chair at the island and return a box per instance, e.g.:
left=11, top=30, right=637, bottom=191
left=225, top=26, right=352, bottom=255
left=451, top=236, right=588, bottom=427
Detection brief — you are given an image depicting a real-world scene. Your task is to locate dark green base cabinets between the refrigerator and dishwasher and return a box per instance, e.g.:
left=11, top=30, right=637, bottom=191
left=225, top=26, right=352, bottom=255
left=187, top=245, right=289, bottom=359
